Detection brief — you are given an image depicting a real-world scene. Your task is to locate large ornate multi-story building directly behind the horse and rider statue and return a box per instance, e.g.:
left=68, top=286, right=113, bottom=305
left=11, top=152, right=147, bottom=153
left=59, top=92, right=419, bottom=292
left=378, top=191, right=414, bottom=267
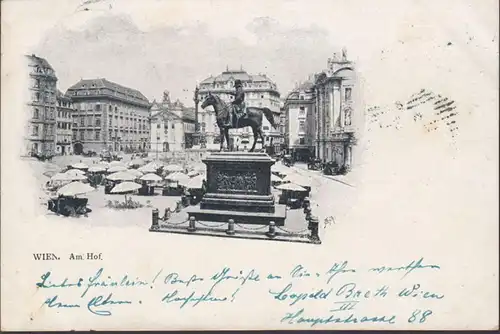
left=199, top=69, right=283, bottom=151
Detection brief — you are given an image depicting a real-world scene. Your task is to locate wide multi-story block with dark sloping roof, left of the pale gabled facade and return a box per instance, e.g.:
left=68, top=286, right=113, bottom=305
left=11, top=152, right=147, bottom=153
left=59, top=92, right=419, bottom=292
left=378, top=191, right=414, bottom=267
left=66, top=79, right=151, bottom=154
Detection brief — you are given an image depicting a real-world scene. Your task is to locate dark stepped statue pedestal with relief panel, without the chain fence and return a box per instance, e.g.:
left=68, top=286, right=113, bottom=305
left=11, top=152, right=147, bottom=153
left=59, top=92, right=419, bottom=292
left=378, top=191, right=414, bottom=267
left=188, top=152, right=286, bottom=226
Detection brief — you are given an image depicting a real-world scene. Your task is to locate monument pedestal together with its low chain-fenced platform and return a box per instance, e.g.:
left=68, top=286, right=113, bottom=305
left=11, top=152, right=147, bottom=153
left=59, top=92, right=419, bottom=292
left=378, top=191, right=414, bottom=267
left=146, top=152, right=321, bottom=244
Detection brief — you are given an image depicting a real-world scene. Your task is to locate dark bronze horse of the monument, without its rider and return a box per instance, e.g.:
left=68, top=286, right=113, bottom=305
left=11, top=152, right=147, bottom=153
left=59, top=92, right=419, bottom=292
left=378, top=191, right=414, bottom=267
left=201, top=92, right=276, bottom=152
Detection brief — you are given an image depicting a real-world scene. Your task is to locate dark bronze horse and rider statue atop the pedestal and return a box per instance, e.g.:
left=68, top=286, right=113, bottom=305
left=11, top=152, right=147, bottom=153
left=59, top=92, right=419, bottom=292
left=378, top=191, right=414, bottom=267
left=201, top=80, right=277, bottom=152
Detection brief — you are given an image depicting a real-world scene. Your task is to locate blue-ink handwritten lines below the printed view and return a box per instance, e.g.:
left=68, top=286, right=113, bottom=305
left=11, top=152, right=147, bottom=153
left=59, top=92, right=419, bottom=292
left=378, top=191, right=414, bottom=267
left=35, top=258, right=445, bottom=327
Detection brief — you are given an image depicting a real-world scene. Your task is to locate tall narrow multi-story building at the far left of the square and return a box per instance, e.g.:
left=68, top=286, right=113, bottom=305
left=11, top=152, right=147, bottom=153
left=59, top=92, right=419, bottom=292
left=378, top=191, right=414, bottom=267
left=22, top=54, right=57, bottom=155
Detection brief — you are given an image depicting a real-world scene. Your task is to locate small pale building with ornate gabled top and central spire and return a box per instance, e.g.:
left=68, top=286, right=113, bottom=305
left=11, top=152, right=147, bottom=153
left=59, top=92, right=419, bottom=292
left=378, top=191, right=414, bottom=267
left=151, top=91, right=195, bottom=152
